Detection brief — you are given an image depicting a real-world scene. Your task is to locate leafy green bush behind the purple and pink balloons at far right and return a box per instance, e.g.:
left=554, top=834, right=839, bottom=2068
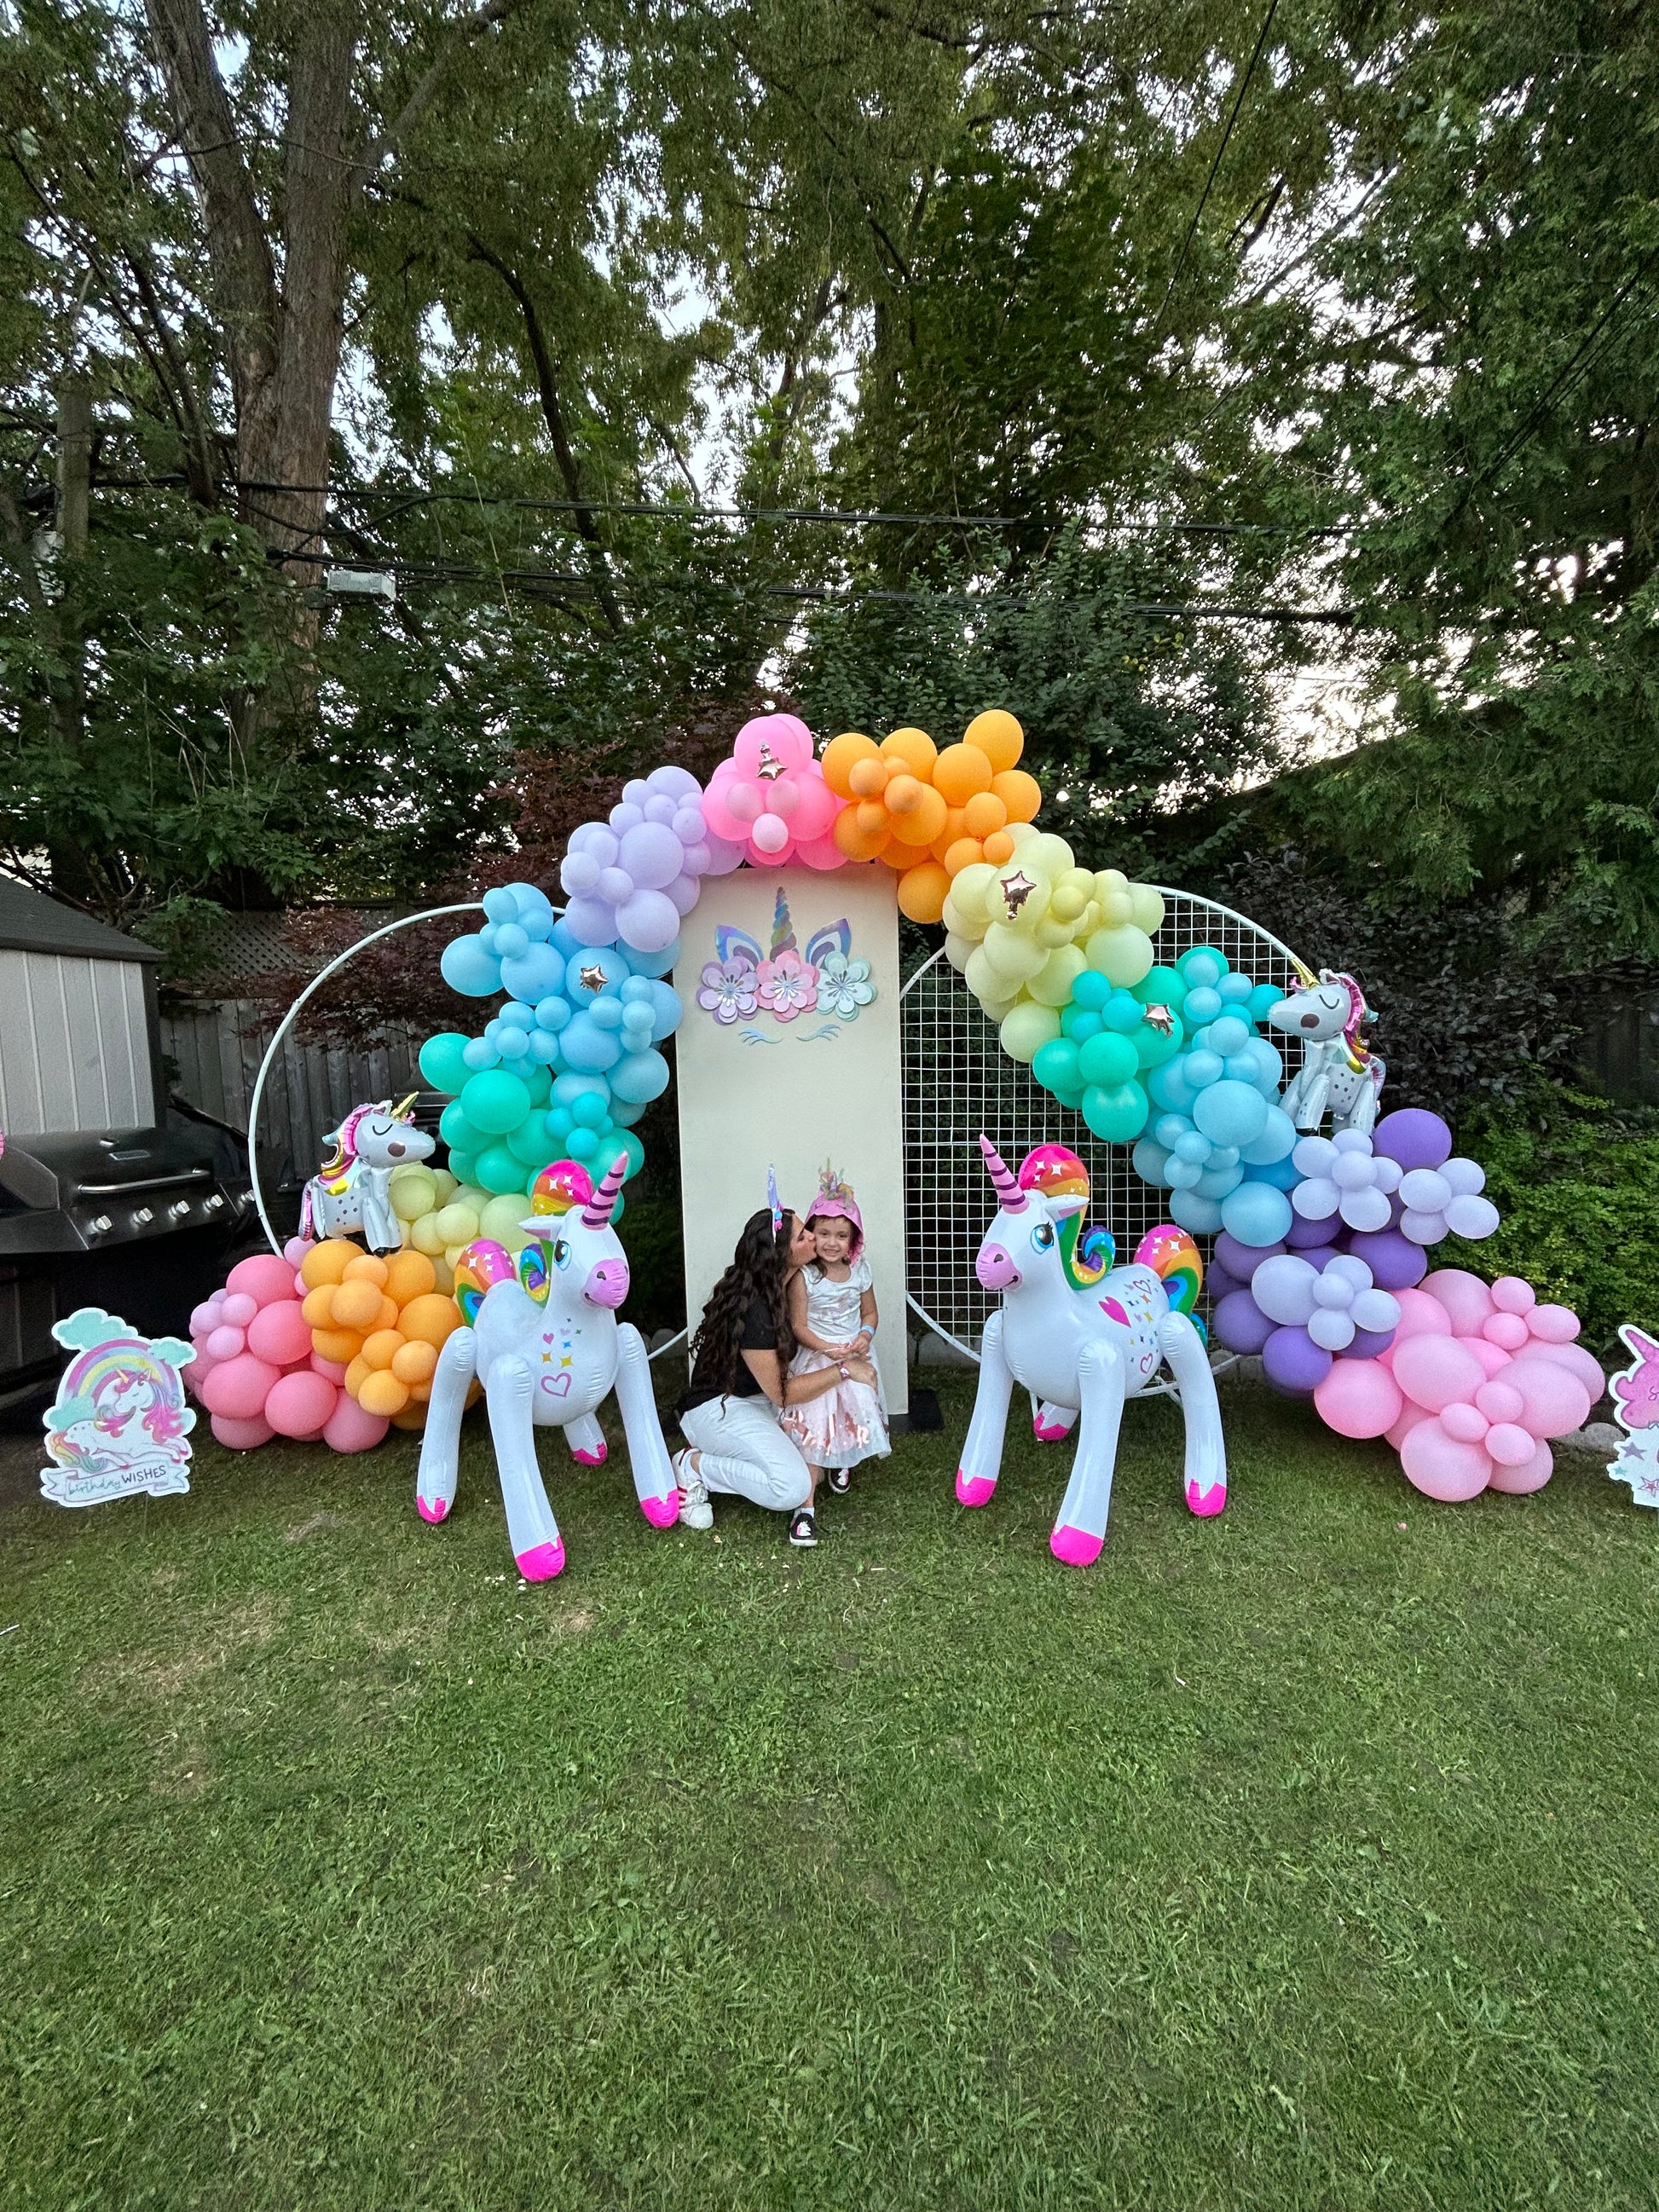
left=1436, top=1084, right=1659, bottom=1367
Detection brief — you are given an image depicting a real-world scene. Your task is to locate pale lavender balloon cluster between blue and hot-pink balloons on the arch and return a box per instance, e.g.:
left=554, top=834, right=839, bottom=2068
left=559, top=760, right=743, bottom=953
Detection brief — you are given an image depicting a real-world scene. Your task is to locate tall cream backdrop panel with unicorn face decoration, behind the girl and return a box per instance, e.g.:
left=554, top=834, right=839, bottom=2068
left=674, top=867, right=909, bottom=1413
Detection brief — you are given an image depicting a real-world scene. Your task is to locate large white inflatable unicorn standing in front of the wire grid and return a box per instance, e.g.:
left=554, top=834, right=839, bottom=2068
left=956, top=1137, right=1228, bottom=1566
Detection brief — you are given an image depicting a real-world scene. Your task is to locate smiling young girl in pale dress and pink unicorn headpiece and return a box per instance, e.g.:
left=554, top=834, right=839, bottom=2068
left=783, top=1164, right=892, bottom=1495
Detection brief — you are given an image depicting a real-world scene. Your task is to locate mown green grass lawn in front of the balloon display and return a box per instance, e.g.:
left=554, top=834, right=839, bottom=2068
left=0, top=1387, right=1659, bottom=2212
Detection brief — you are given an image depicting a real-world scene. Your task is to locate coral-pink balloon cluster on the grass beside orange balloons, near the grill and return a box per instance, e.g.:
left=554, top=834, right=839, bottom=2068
left=183, top=1237, right=387, bottom=1451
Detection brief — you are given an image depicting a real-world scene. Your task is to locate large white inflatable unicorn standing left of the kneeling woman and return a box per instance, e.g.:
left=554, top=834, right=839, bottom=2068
left=416, top=1152, right=679, bottom=1581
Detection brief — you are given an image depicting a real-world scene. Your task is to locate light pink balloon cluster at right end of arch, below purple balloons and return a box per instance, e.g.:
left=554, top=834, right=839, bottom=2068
left=1314, top=1268, right=1604, bottom=1505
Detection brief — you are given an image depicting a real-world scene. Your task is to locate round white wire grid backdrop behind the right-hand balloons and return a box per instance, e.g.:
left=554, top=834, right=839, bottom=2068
left=900, top=892, right=1303, bottom=1349
